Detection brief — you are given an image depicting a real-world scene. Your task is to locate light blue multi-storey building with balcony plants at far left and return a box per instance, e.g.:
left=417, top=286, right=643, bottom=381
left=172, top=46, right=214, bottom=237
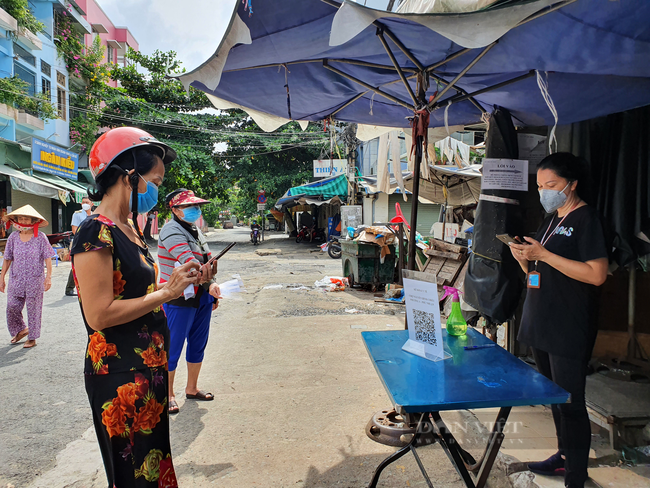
left=0, top=0, right=92, bottom=233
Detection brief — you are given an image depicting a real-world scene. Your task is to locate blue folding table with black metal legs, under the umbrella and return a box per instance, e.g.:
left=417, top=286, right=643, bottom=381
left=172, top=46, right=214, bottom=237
left=361, top=329, right=569, bottom=488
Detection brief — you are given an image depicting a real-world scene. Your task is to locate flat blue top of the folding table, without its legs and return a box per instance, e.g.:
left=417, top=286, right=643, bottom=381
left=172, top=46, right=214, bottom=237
left=361, top=328, right=569, bottom=413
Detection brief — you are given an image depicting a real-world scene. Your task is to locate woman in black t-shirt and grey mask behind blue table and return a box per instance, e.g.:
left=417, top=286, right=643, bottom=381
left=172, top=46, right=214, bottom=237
left=510, top=153, right=608, bottom=488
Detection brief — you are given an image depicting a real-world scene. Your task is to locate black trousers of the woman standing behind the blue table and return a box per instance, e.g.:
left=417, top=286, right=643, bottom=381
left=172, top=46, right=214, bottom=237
left=533, top=348, right=591, bottom=488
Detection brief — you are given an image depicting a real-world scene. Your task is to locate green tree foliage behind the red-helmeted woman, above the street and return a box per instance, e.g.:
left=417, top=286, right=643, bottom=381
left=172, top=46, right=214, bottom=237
left=102, top=50, right=325, bottom=217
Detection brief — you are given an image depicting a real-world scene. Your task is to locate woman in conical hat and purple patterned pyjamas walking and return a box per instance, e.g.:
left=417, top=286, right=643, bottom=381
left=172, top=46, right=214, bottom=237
left=0, top=205, right=54, bottom=348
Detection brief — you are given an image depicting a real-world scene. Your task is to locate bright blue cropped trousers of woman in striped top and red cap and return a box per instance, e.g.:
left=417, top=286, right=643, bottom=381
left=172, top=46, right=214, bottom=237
left=163, top=292, right=214, bottom=371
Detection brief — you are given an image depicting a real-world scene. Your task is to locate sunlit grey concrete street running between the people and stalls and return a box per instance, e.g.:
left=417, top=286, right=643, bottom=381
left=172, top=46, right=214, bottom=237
left=0, top=228, right=510, bottom=488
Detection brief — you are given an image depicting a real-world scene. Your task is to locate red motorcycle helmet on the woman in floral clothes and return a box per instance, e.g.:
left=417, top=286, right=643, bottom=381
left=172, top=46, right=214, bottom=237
left=88, top=127, right=177, bottom=180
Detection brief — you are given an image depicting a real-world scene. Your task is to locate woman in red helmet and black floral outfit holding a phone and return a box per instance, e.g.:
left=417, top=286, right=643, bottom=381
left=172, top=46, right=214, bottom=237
left=72, top=127, right=207, bottom=488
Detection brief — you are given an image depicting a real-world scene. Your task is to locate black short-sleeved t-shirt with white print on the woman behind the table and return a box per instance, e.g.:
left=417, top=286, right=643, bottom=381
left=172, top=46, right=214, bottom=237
left=517, top=205, right=607, bottom=359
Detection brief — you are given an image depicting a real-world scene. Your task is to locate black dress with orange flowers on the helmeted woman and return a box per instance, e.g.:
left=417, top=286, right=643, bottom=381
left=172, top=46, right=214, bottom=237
left=72, top=215, right=178, bottom=488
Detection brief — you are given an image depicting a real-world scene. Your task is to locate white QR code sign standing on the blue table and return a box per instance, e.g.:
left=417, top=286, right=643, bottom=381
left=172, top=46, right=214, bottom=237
left=402, top=272, right=445, bottom=361
